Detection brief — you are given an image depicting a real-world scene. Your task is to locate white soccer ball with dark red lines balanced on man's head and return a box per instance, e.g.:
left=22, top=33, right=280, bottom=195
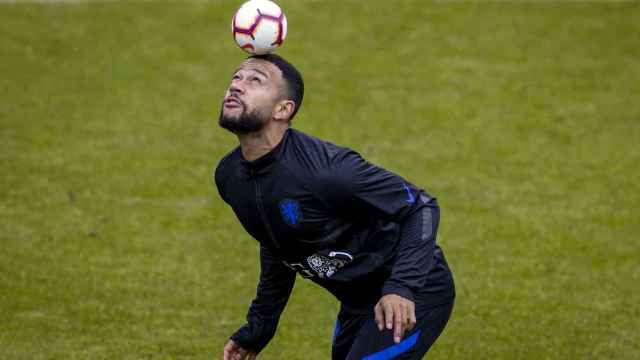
left=231, top=0, right=287, bottom=55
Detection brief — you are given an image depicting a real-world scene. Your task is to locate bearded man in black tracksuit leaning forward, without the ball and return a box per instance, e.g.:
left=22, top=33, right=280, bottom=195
left=215, top=54, right=455, bottom=360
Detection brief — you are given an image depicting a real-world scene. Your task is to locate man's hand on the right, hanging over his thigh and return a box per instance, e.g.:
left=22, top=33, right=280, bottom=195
left=373, top=294, right=416, bottom=343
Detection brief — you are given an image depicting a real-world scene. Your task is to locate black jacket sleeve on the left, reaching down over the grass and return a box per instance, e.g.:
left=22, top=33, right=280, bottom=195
left=231, top=246, right=296, bottom=353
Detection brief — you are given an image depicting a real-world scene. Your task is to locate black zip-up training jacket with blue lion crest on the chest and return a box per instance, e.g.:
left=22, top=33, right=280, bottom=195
left=215, top=129, right=454, bottom=352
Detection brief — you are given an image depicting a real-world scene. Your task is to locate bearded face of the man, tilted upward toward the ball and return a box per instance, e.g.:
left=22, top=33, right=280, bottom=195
left=219, top=59, right=283, bottom=134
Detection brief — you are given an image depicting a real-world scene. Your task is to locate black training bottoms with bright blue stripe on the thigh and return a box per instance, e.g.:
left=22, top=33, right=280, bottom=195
left=331, top=299, right=454, bottom=360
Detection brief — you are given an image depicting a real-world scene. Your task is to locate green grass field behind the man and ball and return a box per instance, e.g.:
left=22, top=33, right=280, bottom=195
left=0, top=0, right=640, bottom=360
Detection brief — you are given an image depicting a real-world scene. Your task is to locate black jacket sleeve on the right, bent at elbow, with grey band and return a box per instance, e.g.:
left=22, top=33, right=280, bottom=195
left=325, top=151, right=439, bottom=300
